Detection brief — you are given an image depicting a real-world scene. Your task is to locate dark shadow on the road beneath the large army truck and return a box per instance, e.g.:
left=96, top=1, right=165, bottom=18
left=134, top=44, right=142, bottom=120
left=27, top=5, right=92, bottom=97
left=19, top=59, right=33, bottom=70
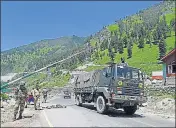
left=82, top=104, right=145, bottom=118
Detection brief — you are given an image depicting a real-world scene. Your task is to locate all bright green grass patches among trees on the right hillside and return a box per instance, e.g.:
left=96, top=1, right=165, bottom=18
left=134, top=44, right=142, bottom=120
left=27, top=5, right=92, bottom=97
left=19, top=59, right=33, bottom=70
left=86, top=8, right=175, bottom=75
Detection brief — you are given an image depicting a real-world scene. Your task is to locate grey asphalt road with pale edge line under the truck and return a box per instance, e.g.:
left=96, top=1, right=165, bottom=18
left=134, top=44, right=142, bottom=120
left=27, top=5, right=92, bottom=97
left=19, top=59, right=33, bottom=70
left=40, top=96, right=175, bottom=127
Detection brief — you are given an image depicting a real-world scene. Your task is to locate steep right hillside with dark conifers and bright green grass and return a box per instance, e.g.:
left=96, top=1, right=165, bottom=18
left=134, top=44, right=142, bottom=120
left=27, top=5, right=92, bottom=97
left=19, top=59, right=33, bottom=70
left=87, top=1, right=175, bottom=74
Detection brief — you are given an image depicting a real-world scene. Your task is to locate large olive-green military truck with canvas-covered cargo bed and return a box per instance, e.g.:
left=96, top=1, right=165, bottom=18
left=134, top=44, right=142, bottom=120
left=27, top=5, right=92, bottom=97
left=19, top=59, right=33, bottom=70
left=74, top=63, right=147, bottom=115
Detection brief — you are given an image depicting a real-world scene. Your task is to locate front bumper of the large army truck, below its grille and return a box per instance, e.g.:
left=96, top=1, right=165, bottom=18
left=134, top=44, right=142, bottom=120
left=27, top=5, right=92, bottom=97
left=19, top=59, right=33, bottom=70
left=111, top=95, right=147, bottom=103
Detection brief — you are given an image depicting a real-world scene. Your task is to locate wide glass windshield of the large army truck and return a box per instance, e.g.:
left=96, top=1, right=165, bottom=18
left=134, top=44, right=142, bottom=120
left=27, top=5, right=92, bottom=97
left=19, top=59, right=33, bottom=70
left=117, top=67, right=139, bottom=79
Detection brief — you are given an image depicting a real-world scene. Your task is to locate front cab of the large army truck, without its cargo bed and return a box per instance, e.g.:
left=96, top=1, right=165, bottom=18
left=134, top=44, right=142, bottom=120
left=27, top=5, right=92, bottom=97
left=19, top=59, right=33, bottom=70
left=99, top=64, right=147, bottom=114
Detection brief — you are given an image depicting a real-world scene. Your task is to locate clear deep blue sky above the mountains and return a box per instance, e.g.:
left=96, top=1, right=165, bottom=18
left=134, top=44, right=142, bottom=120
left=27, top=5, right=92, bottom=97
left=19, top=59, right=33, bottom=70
left=1, top=1, right=159, bottom=51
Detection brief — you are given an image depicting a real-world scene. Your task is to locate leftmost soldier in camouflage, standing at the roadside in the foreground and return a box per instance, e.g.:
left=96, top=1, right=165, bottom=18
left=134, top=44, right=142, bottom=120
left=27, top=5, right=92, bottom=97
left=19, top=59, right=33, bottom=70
left=13, top=81, right=27, bottom=121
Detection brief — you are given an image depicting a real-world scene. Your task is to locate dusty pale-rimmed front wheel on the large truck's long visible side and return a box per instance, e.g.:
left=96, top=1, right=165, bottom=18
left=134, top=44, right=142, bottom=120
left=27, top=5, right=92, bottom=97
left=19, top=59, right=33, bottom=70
left=96, top=96, right=108, bottom=114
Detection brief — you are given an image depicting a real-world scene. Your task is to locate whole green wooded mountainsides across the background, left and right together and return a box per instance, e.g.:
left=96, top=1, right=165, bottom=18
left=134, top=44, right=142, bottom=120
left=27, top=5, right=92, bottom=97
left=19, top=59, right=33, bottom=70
left=1, top=1, right=176, bottom=86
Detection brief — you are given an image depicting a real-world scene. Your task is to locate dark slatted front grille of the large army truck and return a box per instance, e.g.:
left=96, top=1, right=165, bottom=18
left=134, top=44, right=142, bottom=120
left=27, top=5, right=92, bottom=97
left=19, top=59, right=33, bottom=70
left=122, top=86, right=141, bottom=96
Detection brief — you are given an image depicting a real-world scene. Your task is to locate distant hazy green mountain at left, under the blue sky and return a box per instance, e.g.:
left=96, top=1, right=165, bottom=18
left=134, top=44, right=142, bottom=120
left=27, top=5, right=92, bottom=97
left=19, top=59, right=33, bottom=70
left=1, top=35, right=86, bottom=75
